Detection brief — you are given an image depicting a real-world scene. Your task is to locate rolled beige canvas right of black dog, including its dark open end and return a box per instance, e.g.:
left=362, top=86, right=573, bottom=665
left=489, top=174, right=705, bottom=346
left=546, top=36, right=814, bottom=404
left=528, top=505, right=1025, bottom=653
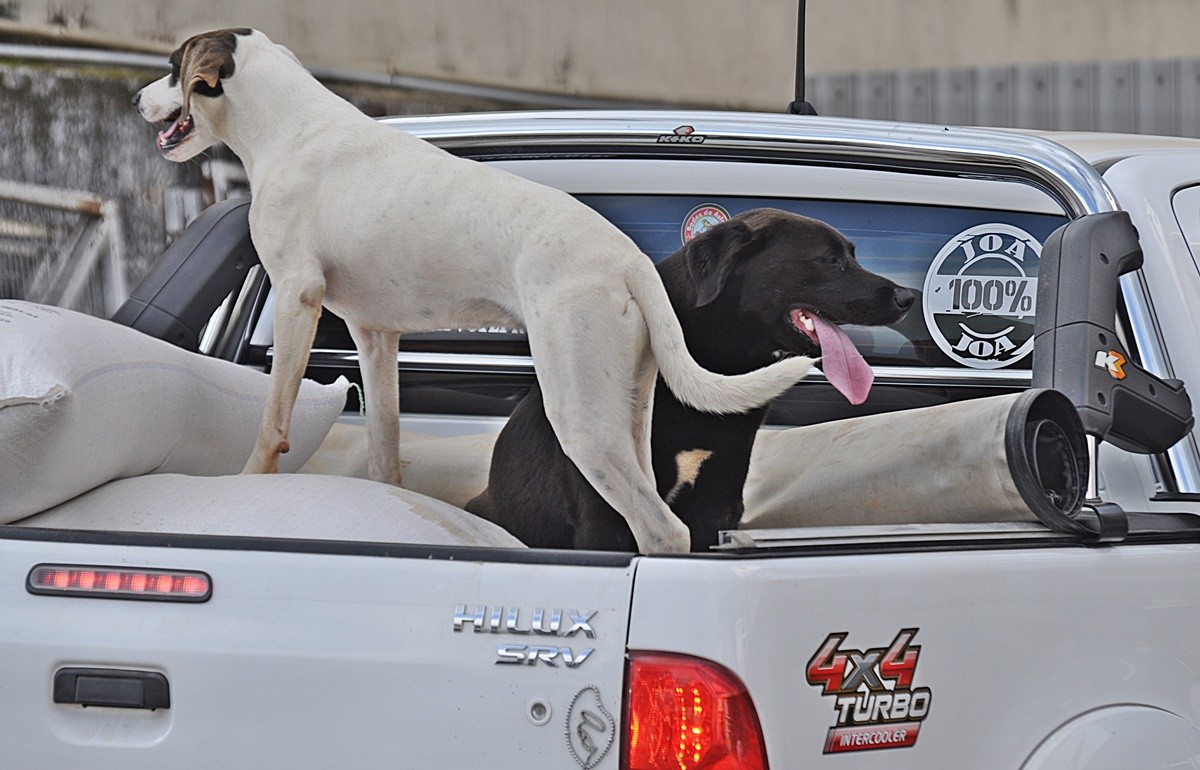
left=740, top=389, right=1088, bottom=530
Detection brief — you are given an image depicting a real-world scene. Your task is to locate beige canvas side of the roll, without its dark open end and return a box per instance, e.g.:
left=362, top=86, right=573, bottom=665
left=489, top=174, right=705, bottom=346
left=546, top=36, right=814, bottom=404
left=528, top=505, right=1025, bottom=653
left=739, top=396, right=1038, bottom=529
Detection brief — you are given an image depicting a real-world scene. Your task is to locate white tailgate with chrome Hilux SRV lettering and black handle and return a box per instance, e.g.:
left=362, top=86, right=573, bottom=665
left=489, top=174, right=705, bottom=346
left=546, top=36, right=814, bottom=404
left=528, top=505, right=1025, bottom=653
left=0, top=531, right=634, bottom=769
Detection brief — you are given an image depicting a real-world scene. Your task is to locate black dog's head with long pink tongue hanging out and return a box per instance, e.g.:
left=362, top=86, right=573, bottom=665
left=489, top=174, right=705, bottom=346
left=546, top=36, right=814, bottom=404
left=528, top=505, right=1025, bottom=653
left=685, top=209, right=916, bottom=403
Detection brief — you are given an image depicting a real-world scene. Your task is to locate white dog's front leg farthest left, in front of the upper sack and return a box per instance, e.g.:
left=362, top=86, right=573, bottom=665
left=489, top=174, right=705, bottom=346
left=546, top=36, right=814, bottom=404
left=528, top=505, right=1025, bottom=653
left=241, top=277, right=325, bottom=474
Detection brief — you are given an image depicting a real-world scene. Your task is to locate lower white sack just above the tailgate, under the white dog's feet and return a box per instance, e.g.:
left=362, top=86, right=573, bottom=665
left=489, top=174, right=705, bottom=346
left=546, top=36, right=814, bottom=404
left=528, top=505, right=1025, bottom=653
left=17, top=474, right=523, bottom=548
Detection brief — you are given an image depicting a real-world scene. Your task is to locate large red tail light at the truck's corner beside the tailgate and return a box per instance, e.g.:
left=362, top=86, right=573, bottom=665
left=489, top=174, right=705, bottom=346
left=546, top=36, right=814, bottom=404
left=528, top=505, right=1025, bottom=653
left=622, top=652, right=767, bottom=770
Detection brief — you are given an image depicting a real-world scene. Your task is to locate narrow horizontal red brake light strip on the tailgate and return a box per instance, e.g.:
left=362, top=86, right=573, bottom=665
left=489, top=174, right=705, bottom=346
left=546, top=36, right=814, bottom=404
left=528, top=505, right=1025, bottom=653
left=25, top=564, right=212, bottom=602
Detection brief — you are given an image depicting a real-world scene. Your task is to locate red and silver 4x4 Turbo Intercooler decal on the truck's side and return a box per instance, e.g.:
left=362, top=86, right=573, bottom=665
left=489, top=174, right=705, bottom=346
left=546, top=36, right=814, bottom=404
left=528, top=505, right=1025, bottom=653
left=804, top=628, right=934, bottom=754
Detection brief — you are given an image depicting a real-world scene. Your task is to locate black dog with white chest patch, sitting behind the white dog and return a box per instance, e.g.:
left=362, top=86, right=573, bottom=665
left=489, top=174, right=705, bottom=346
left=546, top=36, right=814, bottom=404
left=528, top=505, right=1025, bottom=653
left=467, top=209, right=914, bottom=551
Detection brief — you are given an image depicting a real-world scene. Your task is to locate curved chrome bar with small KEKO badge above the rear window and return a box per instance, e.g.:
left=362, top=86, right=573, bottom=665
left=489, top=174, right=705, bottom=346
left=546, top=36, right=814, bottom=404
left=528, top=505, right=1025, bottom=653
left=383, top=110, right=1118, bottom=217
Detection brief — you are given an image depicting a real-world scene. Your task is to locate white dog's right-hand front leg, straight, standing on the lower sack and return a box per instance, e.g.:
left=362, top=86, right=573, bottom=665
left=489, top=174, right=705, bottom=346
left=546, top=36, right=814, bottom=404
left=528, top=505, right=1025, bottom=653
left=347, top=324, right=401, bottom=487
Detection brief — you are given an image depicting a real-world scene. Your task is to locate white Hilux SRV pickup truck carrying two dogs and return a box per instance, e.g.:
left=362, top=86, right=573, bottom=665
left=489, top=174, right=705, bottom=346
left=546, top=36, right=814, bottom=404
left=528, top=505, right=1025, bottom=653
left=0, top=112, right=1200, bottom=770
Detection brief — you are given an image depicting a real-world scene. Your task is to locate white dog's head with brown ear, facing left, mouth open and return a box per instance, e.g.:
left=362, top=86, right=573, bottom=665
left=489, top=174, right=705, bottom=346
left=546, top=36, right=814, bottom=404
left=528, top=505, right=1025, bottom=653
left=133, top=29, right=299, bottom=162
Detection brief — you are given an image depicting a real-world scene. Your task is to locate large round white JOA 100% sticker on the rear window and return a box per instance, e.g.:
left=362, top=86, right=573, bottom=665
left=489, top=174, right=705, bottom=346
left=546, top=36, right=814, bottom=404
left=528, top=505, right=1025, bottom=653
left=922, top=223, right=1042, bottom=369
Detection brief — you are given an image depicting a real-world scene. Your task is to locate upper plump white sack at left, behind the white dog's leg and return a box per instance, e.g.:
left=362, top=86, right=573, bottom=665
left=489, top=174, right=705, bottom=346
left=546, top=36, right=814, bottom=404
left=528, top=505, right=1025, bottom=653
left=0, top=300, right=348, bottom=523
